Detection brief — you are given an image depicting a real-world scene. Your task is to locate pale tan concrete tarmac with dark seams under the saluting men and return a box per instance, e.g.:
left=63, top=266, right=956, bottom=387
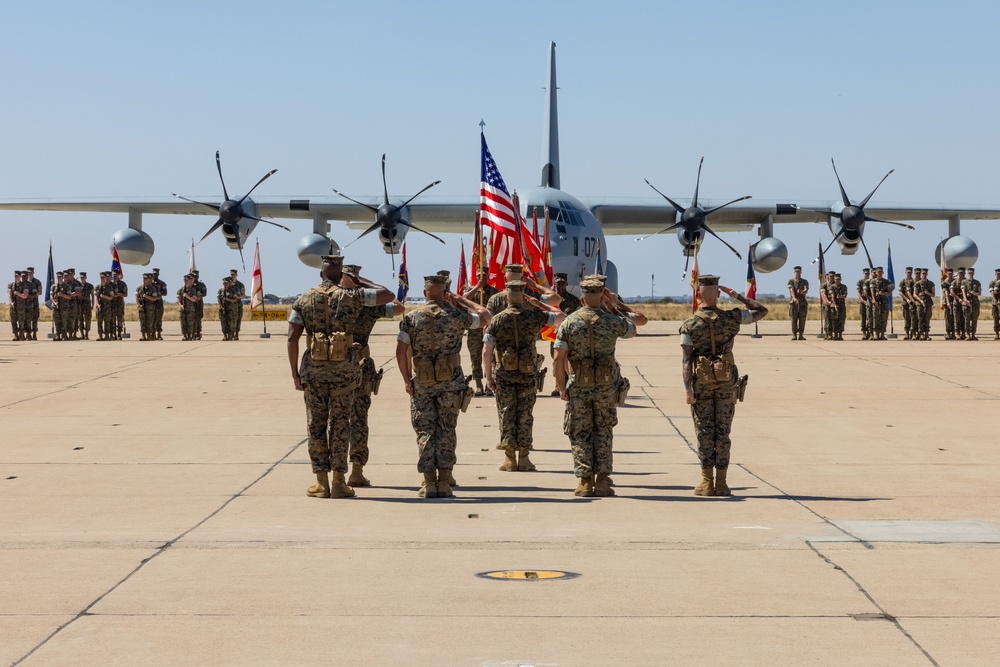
left=0, top=322, right=1000, bottom=666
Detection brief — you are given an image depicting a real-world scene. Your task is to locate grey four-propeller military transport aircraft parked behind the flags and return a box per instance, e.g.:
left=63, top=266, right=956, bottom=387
left=0, top=43, right=1000, bottom=289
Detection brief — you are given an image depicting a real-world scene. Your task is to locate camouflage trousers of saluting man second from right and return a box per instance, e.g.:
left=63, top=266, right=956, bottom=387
left=563, top=385, right=618, bottom=477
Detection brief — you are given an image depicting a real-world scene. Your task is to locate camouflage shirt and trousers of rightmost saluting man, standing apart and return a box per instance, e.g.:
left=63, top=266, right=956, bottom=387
left=680, top=307, right=753, bottom=469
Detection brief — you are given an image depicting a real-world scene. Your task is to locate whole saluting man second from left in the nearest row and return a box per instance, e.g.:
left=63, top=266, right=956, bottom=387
left=396, top=275, right=490, bottom=498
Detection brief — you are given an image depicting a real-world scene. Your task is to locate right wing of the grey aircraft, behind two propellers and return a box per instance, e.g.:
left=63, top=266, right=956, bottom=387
left=580, top=198, right=1000, bottom=235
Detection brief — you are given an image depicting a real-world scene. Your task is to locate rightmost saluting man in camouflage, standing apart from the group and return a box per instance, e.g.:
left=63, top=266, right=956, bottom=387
left=680, top=275, right=767, bottom=496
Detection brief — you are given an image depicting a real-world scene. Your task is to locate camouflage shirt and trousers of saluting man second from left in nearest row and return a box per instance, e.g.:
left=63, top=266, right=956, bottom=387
left=398, top=301, right=479, bottom=473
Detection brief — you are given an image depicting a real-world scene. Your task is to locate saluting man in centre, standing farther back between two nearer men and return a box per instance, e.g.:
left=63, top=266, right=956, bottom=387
left=482, top=280, right=566, bottom=472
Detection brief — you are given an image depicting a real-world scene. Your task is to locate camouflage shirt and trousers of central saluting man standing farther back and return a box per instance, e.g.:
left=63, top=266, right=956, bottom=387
left=483, top=304, right=556, bottom=450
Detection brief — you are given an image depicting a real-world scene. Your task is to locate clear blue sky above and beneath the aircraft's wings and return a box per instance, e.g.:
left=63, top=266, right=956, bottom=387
left=0, top=0, right=1000, bottom=295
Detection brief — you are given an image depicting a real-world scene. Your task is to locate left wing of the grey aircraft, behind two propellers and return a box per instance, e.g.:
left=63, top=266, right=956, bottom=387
left=0, top=196, right=479, bottom=233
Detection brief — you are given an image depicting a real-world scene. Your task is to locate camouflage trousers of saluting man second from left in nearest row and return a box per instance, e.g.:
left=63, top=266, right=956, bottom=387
left=410, top=383, right=463, bottom=472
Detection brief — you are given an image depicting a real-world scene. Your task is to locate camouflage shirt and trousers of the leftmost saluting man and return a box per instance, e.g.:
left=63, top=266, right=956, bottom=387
left=288, top=280, right=377, bottom=473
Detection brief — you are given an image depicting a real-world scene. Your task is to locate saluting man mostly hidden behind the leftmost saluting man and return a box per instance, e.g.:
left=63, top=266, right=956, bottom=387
left=340, top=264, right=404, bottom=486
